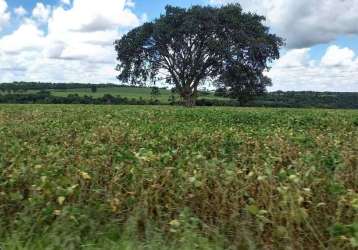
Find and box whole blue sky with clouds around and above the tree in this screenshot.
[0,0,358,92]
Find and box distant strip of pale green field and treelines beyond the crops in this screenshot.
[0,83,358,108]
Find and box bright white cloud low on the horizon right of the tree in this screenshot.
[268,45,358,91]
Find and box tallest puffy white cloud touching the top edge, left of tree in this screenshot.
[43,0,141,62]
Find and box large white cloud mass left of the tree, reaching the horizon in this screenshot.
[0,0,143,82]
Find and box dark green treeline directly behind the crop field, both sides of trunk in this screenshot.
[0,90,358,109]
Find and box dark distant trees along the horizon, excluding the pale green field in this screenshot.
[0,82,358,109]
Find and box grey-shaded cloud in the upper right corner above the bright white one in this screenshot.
[210,0,358,49]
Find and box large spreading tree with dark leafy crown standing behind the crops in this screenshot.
[115,4,283,106]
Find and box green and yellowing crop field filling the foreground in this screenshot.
[0,105,358,250]
